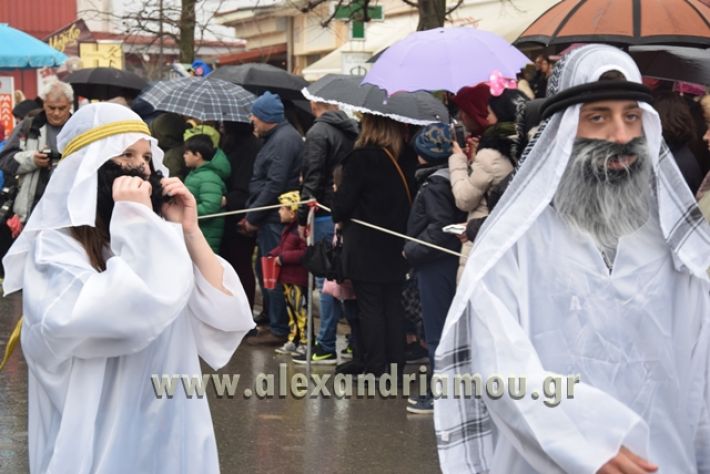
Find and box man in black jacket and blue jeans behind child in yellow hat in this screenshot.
[294,101,358,364]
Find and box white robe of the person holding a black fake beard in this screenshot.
[22,202,253,474]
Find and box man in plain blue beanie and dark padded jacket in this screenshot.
[239,91,303,345]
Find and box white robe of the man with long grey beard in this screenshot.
[469,207,710,474]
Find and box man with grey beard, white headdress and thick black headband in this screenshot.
[434,45,710,474]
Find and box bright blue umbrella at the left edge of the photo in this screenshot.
[0,23,67,69]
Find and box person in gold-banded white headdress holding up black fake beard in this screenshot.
[3,104,253,473]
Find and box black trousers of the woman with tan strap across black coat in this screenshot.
[353,281,404,376]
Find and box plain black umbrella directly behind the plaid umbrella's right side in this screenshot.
[207,63,308,100]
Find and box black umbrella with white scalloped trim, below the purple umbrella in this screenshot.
[302,74,449,125]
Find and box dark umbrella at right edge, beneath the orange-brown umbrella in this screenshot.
[629,46,710,85]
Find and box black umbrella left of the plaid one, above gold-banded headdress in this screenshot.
[64,67,148,100]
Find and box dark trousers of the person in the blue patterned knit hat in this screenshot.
[416,256,459,372]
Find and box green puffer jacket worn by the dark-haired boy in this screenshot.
[185,149,231,253]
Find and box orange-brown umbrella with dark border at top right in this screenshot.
[515,0,710,47]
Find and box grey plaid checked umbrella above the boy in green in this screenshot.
[140,77,256,122]
